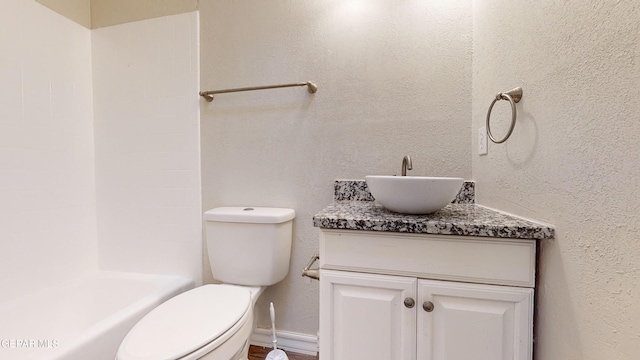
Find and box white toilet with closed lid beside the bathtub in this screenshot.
[116,207,295,360]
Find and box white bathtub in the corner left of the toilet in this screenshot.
[0,271,194,360]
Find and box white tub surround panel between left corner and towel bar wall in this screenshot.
[92,12,202,281]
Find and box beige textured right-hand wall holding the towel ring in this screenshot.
[473,0,640,360]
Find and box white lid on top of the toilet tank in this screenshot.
[204,206,296,224]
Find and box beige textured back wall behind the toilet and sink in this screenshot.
[199,0,472,335]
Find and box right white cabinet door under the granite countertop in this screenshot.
[417,280,533,360]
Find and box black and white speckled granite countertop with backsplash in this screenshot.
[313,180,555,239]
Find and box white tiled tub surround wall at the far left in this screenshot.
[0,0,97,302]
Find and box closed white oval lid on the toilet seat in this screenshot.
[117,285,251,360]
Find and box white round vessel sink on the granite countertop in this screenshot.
[364,175,464,214]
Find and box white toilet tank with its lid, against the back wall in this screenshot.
[204,207,295,286]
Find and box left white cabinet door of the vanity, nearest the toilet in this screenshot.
[320,270,417,360]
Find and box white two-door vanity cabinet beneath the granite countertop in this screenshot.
[319,229,536,360]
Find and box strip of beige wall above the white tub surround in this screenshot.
[36,0,198,29]
